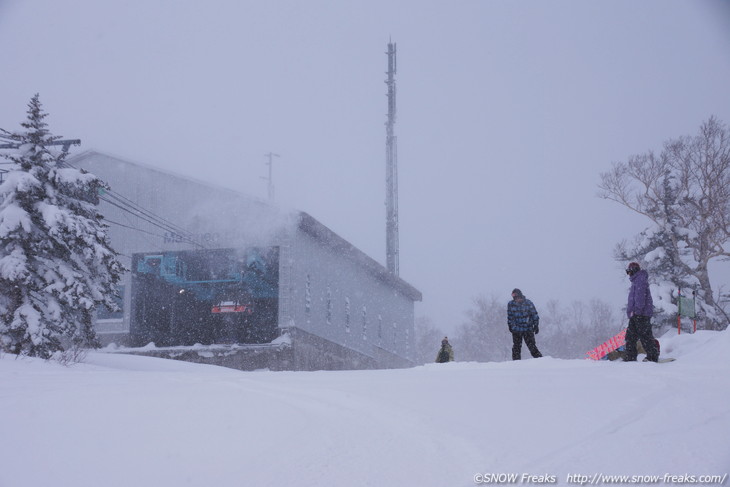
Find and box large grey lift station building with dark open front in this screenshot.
[68,151,421,370]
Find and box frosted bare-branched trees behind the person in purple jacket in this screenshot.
[599,117,730,329]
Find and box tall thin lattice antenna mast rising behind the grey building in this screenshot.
[385,42,400,276]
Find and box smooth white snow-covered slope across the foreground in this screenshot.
[0,331,730,487]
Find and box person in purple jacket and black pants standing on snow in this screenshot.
[624,262,659,362]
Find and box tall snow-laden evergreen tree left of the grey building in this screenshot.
[0,94,123,358]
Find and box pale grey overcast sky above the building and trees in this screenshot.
[0,0,730,330]
